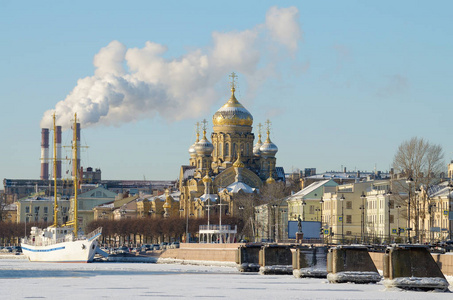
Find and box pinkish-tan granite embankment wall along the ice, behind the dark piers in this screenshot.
[153,243,453,276]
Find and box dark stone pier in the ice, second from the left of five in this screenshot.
[259,245,293,275]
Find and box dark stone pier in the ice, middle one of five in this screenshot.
[291,246,327,278]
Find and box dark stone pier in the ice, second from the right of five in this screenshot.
[327,246,381,283]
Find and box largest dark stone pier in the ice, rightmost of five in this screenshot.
[384,245,448,291]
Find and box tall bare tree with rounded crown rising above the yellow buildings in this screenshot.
[392,137,445,241]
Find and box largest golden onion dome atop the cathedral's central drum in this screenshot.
[212,87,253,126]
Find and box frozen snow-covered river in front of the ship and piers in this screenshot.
[0,259,453,300]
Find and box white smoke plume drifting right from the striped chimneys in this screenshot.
[41,7,302,128]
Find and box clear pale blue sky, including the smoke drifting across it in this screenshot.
[0,1,453,188]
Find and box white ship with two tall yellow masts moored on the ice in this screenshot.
[21,114,102,263]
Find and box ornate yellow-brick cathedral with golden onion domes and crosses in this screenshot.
[179,73,285,218]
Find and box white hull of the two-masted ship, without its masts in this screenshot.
[21,239,98,263]
